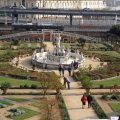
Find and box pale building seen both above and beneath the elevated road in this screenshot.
[0,0,106,22]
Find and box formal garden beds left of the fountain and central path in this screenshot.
[0,40,69,120]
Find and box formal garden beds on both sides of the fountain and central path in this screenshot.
[0,24,120,120]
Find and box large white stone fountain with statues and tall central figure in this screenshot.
[32,34,85,69]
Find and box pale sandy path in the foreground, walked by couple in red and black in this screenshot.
[61,77,98,120]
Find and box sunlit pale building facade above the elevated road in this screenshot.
[0,0,106,9]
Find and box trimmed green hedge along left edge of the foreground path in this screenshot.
[56,94,70,120]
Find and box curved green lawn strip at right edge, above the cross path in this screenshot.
[93,78,120,87]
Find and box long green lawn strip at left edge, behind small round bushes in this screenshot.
[0,77,40,87]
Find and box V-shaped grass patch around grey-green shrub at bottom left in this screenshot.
[12,107,39,120]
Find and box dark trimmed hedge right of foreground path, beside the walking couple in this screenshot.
[92,99,108,119]
